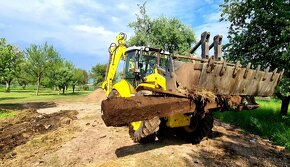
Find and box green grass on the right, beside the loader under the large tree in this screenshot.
[214,100,290,150]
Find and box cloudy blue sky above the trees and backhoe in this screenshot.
[0,0,228,70]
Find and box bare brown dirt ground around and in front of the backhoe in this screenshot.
[0,90,290,167]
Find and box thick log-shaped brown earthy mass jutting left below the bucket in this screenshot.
[102,96,195,126]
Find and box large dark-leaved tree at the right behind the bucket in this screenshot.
[221,0,290,115]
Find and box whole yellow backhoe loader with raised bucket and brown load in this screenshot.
[101,32,283,143]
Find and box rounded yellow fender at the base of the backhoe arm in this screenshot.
[113,79,136,97]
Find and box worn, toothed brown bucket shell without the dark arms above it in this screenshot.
[175,59,283,96]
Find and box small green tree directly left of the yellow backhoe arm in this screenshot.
[90,64,107,86]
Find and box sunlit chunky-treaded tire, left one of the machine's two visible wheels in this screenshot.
[129,117,160,144]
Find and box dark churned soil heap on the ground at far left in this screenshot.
[0,109,78,160]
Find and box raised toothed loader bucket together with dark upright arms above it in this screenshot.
[169,31,283,96]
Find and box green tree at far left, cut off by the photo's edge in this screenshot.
[0,38,23,92]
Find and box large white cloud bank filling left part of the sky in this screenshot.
[0,0,137,55]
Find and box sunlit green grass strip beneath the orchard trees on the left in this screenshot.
[0,89,92,104]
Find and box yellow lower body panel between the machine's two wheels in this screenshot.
[166,114,191,128]
